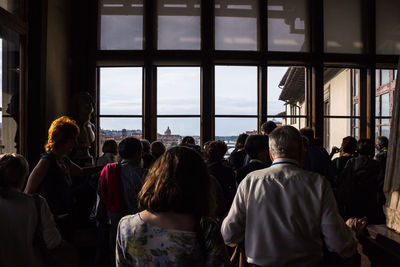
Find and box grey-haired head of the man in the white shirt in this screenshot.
[268,125,303,159]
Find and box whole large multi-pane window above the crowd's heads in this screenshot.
[96,0,400,154]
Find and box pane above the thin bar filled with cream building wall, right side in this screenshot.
[324,68,355,116]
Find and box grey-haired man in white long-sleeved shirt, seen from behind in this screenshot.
[221,126,357,266]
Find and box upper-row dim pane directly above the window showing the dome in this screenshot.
[157,0,201,50]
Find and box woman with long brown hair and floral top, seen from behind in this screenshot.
[116,147,226,266]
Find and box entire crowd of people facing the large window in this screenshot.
[0,116,388,266]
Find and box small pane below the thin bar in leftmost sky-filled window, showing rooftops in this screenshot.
[99,118,142,152]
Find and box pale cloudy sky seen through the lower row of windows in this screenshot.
[100,66,287,136]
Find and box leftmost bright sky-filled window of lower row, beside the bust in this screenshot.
[99,67,143,151]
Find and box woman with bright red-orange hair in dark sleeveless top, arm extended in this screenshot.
[25,116,103,238]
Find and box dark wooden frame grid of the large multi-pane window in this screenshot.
[95,0,397,155]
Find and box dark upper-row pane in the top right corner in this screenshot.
[376,0,400,55]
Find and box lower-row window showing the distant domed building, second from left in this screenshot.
[157,67,200,148]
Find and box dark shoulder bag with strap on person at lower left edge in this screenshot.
[33,194,77,267]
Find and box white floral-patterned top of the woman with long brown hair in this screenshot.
[116,214,225,267]
